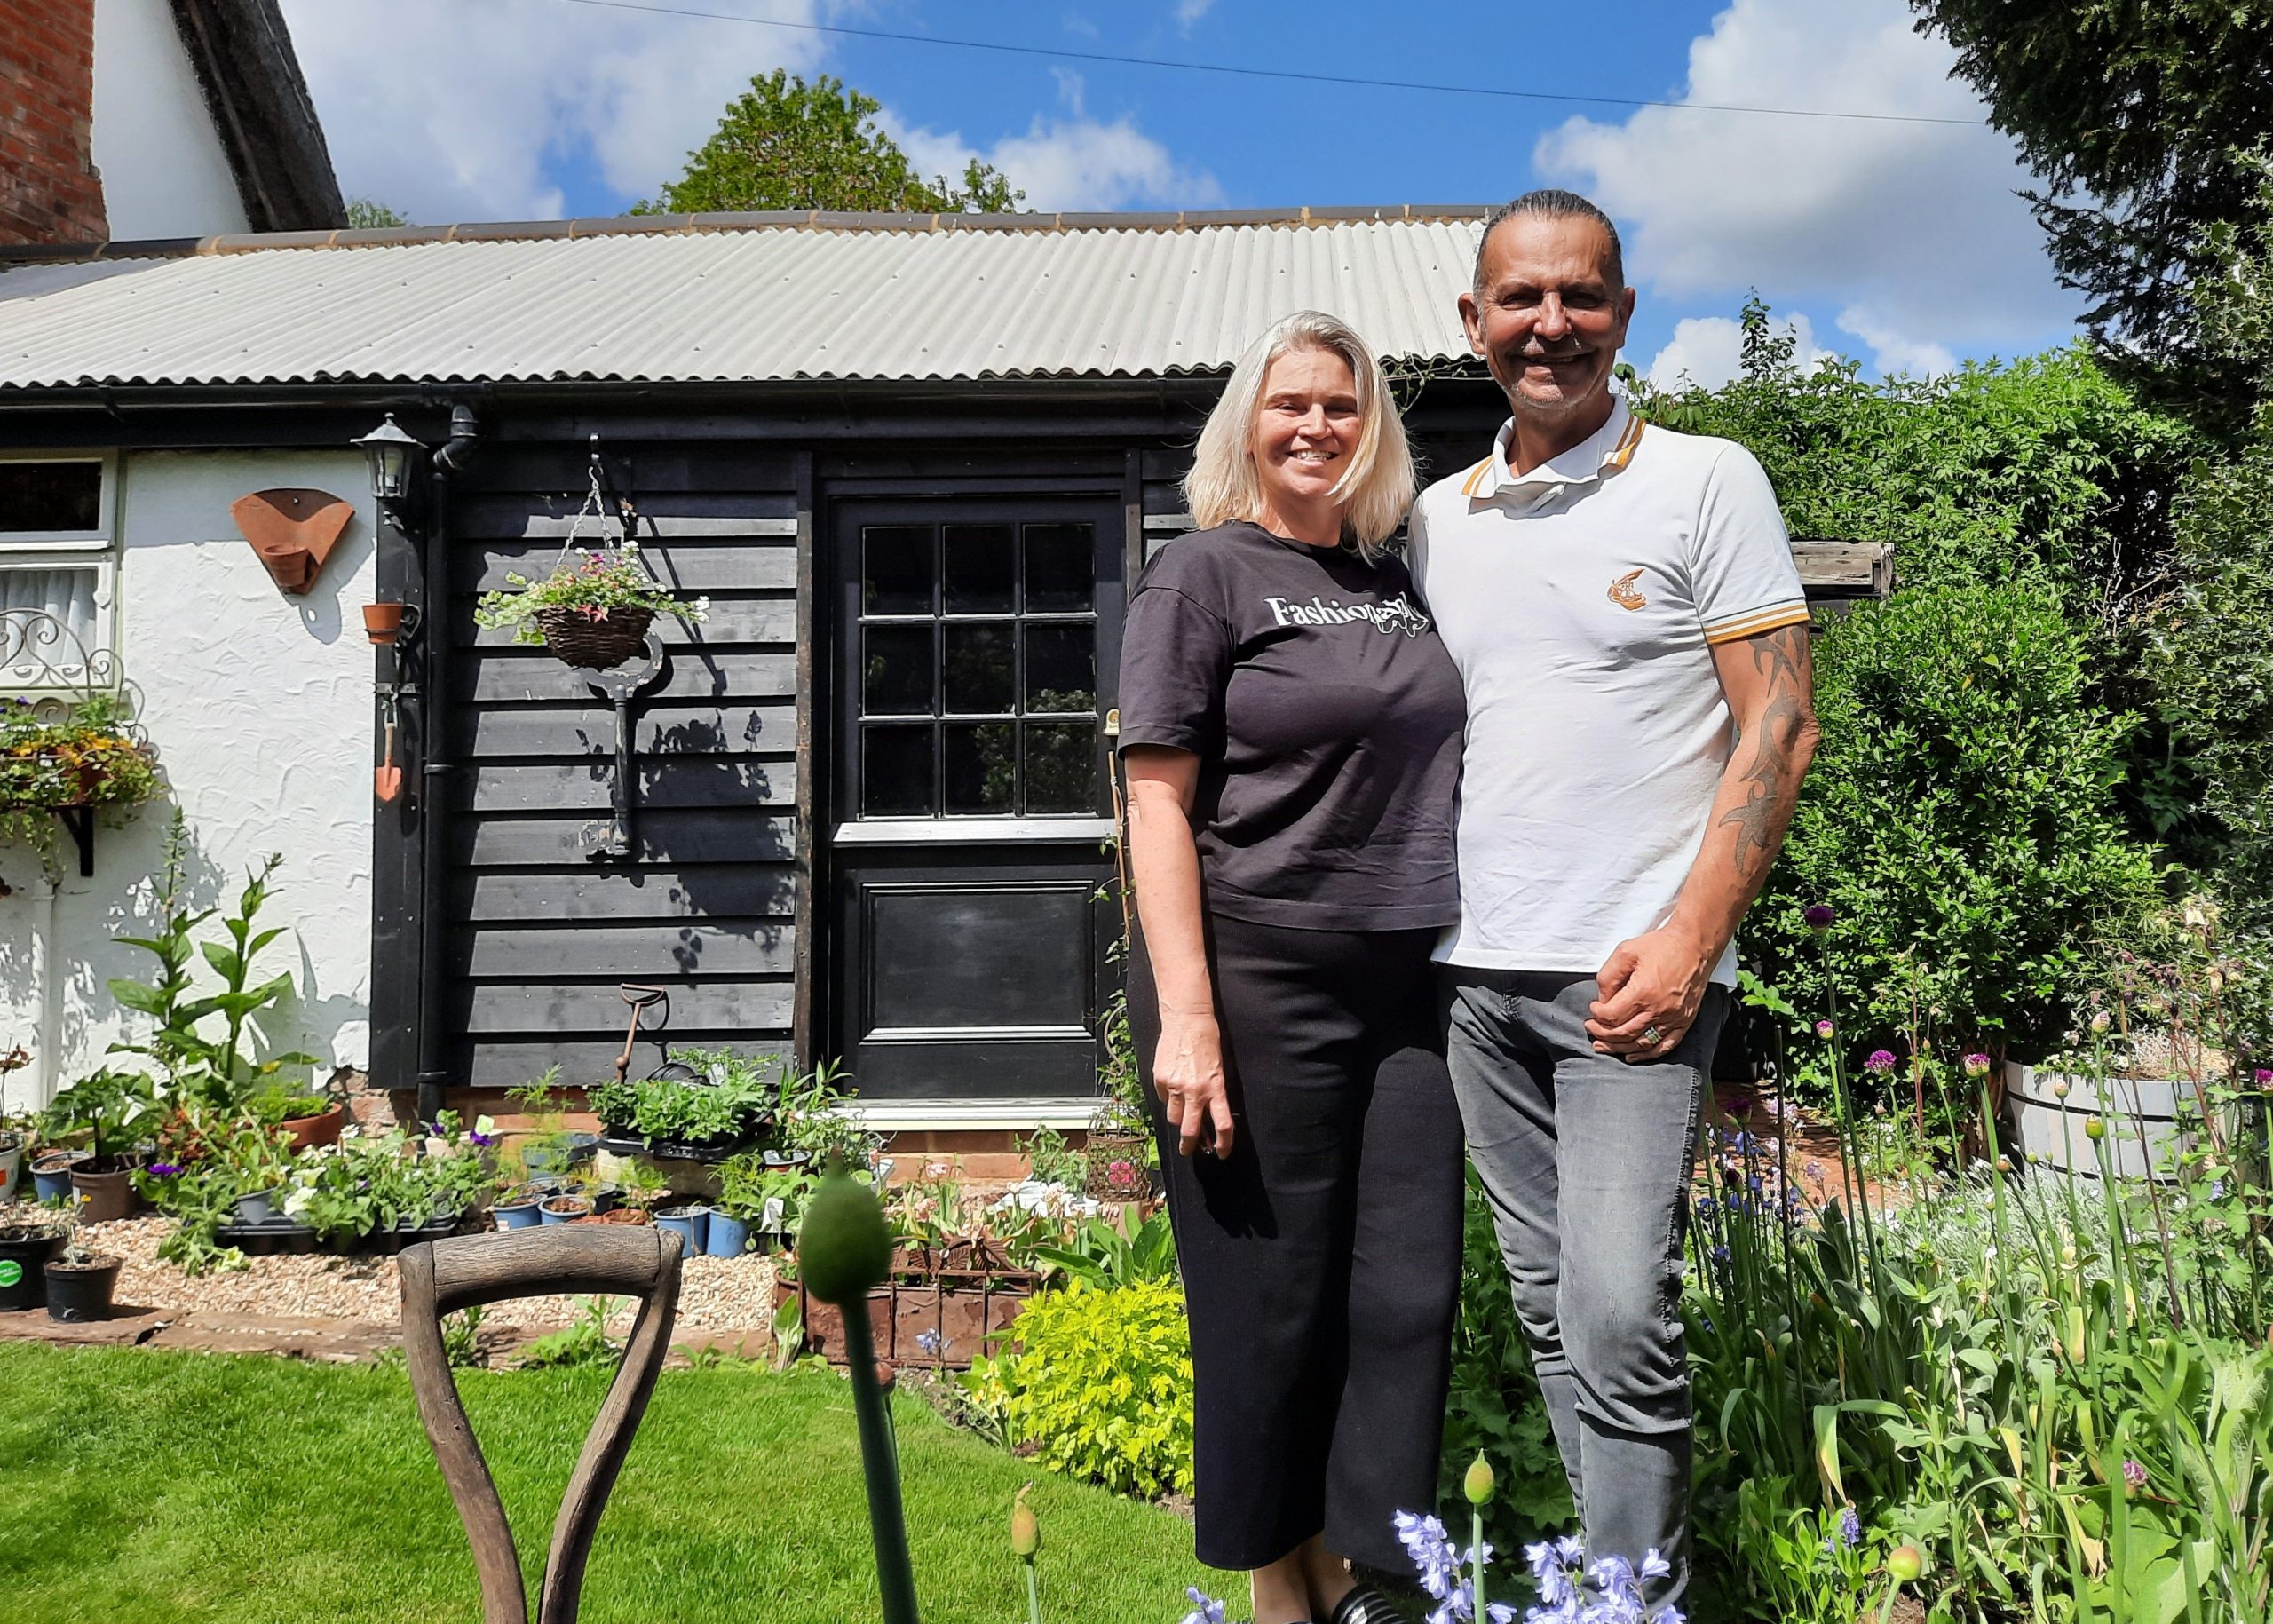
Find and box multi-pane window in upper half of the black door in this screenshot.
[857,523,1097,817]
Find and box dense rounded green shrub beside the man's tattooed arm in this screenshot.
[1746,584,2155,1058]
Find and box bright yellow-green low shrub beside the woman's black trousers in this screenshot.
[966,1280,1191,1497]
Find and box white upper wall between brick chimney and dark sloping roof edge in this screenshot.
[89,0,250,242]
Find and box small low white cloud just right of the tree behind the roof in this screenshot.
[880,112,1223,211]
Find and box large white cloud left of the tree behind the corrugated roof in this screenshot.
[284,0,825,223]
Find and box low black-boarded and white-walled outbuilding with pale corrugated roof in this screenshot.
[0,207,1887,1129]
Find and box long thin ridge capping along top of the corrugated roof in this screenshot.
[0,202,1489,264]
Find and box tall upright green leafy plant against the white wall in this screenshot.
[109,807,316,1105]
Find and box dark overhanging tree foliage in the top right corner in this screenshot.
[1912,0,2273,423]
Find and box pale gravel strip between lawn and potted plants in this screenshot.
[84,1216,772,1331]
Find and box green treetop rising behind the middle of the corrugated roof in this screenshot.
[634,68,1026,214]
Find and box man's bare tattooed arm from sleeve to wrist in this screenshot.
[1668,623,1816,960]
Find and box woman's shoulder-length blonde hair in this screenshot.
[1184,309,1414,559]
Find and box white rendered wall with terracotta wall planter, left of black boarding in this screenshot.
[0,450,373,1110]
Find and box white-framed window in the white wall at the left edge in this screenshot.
[0,450,118,693]
